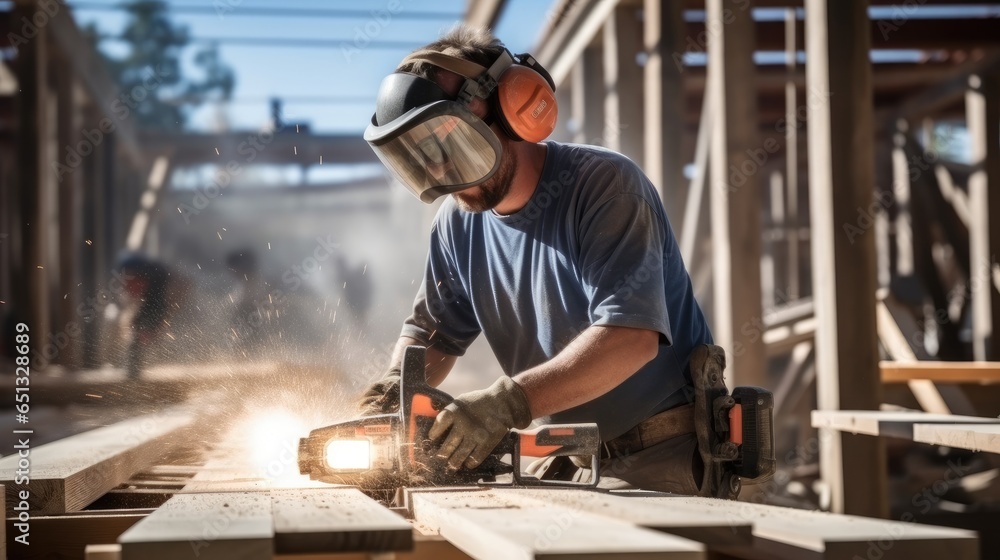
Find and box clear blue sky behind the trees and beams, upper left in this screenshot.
[68,0,553,133]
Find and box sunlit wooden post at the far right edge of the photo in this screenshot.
[965,75,1000,360]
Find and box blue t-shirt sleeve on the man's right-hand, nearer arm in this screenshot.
[580,193,673,344]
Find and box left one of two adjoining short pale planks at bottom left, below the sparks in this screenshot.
[118,493,274,560]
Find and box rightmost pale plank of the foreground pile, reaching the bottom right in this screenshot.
[646,497,979,560]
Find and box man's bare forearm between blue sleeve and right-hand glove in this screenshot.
[514,326,660,418]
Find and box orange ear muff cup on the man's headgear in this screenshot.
[497,64,559,142]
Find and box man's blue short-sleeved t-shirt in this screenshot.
[402,142,712,440]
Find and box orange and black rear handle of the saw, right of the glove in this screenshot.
[510,424,601,488]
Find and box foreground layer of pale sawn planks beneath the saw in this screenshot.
[0,412,978,560]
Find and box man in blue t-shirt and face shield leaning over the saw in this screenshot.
[361,26,712,494]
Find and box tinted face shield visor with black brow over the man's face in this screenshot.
[365,73,502,203]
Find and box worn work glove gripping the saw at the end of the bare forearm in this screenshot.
[427,376,531,470]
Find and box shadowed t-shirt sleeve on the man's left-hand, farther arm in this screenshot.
[401,225,481,356]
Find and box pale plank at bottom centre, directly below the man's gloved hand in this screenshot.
[409,489,705,560]
